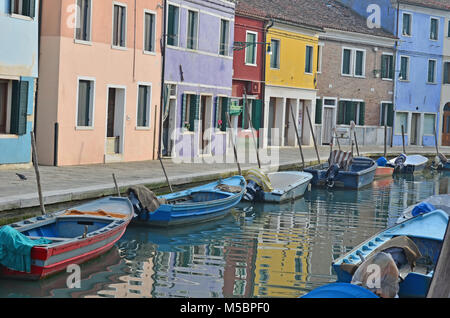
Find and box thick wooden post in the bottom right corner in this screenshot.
[427,221,450,298]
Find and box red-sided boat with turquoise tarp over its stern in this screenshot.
[0,197,134,280]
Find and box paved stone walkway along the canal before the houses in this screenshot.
[0,146,450,218]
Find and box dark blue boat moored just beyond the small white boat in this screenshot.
[304,157,377,189]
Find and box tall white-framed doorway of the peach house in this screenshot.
[106,87,125,156]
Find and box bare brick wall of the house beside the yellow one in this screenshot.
[317,39,394,126]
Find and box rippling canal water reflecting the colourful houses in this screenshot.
[0,172,450,298]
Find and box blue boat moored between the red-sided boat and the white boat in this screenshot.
[129,176,247,227]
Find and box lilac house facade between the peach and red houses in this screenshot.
[162,0,235,158]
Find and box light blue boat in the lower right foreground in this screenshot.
[332,210,449,298]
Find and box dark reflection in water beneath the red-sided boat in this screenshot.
[0,246,126,298]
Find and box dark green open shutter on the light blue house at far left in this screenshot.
[11,81,29,136]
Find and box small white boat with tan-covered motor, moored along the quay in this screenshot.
[244,169,313,203]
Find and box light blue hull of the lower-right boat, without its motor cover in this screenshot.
[332,210,449,298]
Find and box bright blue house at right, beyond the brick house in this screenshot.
[341,0,449,146]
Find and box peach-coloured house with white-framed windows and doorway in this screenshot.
[36,0,163,166]
